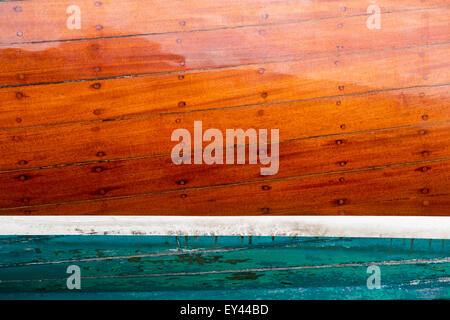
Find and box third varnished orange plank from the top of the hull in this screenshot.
[0,45,450,129]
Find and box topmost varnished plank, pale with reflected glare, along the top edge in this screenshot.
[0,0,448,43]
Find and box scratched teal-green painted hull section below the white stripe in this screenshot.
[0,236,450,299]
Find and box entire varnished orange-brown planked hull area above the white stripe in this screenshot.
[0,0,450,215]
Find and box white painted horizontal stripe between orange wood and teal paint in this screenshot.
[0,216,450,239]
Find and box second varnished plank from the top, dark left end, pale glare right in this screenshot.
[0,7,450,86]
